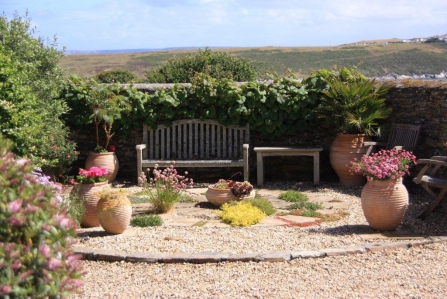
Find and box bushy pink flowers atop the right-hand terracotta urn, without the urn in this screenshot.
[350,149,416,181]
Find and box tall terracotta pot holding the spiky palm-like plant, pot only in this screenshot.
[329,134,372,186]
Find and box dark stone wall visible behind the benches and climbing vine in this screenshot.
[72,80,447,183]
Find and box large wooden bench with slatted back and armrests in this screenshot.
[136,119,250,181]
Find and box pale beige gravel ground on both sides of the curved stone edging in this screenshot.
[68,183,447,298]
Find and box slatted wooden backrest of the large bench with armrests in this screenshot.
[143,119,250,160]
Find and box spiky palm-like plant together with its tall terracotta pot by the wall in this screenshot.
[316,68,391,186]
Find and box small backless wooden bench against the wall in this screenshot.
[254,147,323,187]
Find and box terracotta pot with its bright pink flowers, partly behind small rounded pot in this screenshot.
[71,167,109,227]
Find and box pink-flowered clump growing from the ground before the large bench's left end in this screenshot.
[138,162,194,213]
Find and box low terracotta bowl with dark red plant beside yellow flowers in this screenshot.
[205,179,255,207]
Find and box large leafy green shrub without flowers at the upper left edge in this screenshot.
[0,12,77,177]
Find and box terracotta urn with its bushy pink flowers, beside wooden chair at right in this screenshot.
[351,149,416,230]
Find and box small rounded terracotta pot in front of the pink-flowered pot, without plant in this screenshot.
[96,193,132,234]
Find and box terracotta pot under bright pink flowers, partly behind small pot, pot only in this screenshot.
[71,182,109,227]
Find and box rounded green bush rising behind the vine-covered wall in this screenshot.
[146,49,257,83]
